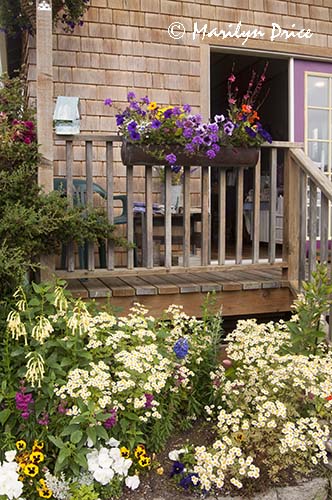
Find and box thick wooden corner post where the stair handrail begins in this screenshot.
[283,149,303,288]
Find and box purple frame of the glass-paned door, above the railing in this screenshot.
[294,59,332,142]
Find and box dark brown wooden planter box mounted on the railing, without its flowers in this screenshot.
[121,141,259,168]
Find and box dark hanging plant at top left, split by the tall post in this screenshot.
[0,0,90,35]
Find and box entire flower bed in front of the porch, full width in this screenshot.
[0,266,332,500]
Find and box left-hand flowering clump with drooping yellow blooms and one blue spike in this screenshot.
[0,284,220,499]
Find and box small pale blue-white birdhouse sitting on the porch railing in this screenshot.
[53,96,81,135]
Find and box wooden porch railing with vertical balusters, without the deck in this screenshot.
[55,135,332,285]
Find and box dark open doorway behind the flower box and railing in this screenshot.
[210,51,289,258]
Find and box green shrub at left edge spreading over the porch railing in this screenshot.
[0,76,125,298]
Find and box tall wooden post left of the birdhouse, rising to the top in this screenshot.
[36,0,55,280]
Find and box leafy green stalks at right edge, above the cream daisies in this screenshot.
[287,264,332,356]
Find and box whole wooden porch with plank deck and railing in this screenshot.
[50,135,332,328]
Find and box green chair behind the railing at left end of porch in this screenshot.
[53,177,128,269]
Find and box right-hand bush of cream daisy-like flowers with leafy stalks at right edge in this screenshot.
[171,266,332,494]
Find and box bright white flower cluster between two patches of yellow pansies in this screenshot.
[86,439,140,490]
